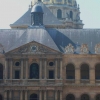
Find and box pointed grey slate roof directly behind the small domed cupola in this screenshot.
[10,2,62,26]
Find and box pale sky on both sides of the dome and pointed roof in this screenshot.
[0,0,100,29]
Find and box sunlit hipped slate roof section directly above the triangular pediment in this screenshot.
[6,28,60,52]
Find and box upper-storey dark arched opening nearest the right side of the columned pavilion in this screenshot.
[66,64,75,79]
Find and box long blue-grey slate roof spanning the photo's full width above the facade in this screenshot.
[0,27,100,54]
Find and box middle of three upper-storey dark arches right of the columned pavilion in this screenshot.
[81,64,89,79]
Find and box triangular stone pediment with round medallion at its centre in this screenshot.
[9,42,60,54]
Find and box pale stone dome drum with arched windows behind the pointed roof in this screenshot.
[32,0,84,28]
